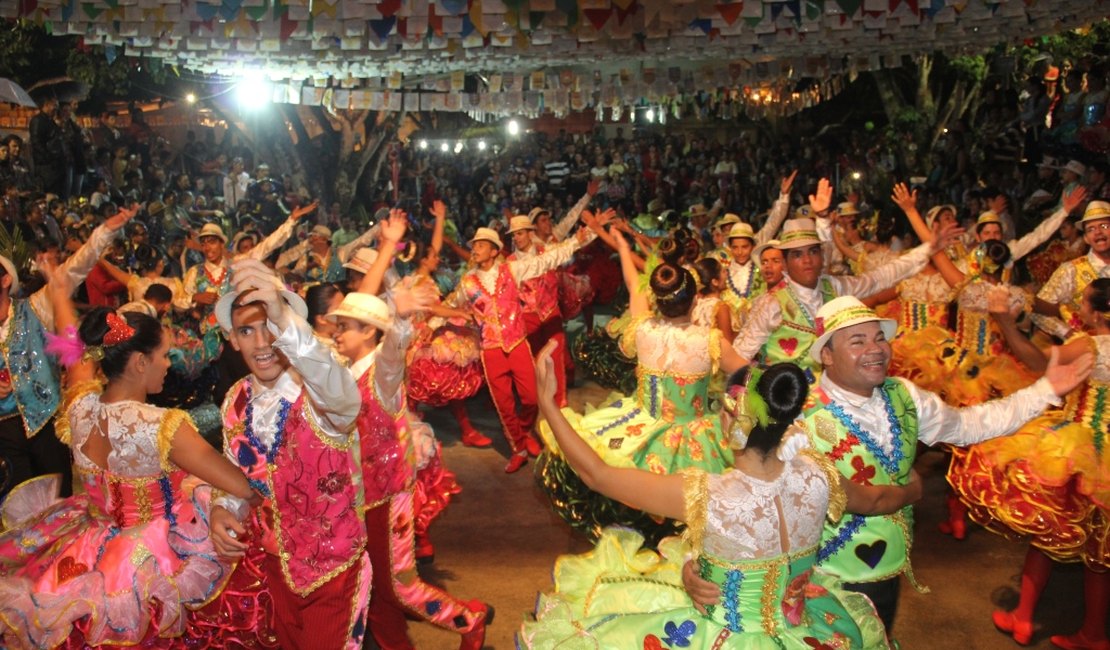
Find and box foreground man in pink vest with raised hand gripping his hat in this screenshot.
[204,260,371,650]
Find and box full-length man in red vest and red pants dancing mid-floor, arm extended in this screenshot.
[446,216,595,474]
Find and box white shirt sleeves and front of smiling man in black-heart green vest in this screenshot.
[810,373,1061,453]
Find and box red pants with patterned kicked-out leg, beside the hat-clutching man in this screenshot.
[366,490,485,650]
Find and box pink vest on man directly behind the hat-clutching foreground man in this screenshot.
[356,365,413,508]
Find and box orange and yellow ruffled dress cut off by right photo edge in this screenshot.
[948,335,1110,570]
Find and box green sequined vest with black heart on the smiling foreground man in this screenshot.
[804,378,917,586]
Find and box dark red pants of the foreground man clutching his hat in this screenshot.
[262,545,370,650]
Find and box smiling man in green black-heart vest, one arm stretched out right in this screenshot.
[683,296,1093,633]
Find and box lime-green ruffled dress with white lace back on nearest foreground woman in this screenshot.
[517,451,889,650]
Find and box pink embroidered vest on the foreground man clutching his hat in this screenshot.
[223,377,366,597]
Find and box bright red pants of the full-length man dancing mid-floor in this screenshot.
[482,342,536,454]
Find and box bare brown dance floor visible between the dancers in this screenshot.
[399,383,1082,650]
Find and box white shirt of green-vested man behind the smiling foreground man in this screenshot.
[733,244,931,360]
